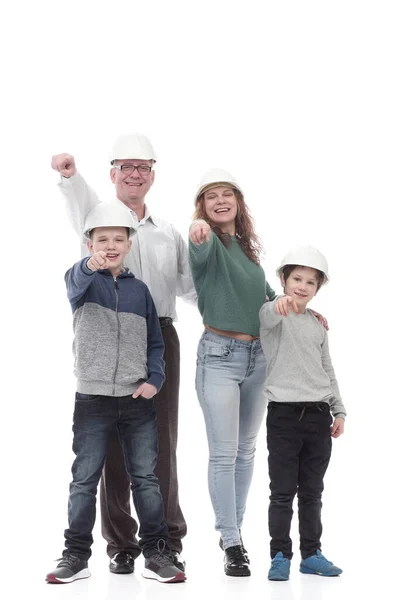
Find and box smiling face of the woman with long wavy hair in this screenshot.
[201,185,238,235]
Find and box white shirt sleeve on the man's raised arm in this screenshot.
[58,172,100,257]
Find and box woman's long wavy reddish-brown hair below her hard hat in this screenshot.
[193,184,263,265]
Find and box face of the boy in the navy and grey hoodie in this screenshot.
[87,227,132,277]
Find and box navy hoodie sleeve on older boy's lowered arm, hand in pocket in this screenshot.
[146,288,165,391]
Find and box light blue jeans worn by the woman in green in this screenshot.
[196,331,267,548]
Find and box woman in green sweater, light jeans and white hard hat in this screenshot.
[189,169,276,577]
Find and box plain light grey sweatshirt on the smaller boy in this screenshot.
[259,300,346,418]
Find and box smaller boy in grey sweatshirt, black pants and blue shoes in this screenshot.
[260,246,346,581]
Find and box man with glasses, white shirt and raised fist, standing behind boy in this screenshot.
[51,134,196,574]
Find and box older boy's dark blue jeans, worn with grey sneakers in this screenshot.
[64,392,168,559]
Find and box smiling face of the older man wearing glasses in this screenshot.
[110,158,155,208]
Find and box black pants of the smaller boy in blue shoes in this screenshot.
[267,402,332,559]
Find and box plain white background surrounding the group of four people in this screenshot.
[0,0,403,600]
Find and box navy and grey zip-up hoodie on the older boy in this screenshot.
[65,256,165,396]
